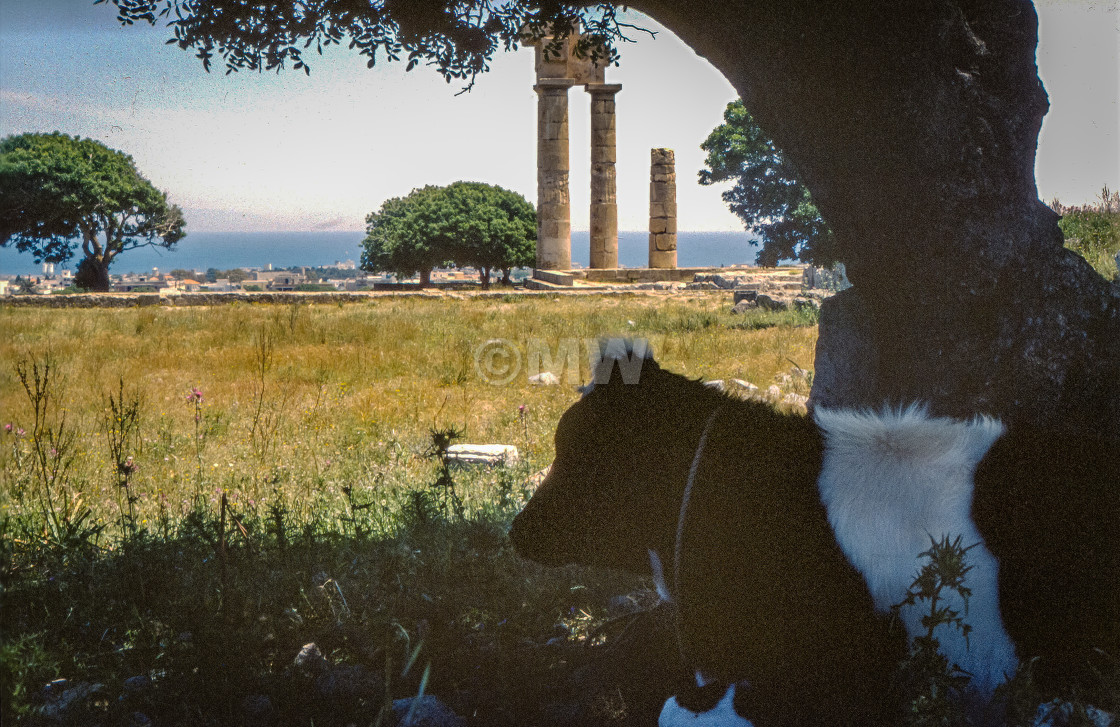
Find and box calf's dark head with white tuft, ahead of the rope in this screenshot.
[510,341,725,574]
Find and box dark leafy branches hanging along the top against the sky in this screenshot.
[95,0,627,87]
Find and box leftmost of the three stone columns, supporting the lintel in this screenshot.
[533,78,575,270]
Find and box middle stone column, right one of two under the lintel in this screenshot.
[585,83,622,268]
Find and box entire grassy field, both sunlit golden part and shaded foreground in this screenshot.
[0,296,816,725]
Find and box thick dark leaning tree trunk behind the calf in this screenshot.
[634,0,1120,436]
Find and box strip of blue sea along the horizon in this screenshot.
[0,231,758,276]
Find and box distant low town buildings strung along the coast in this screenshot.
[0,260,532,296]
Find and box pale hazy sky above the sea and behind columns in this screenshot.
[0,0,1120,231]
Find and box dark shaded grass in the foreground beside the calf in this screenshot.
[0,499,675,726]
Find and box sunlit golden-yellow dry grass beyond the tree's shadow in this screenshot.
[0,298,815,529]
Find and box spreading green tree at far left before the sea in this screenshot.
[0,132,186,290]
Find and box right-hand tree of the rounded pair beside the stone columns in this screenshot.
[445,181,536,290]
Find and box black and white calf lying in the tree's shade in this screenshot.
[511,342,1120,727]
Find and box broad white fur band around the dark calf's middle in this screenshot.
[814,406,1018,693]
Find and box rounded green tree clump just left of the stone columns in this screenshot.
[362,181,536,288]
